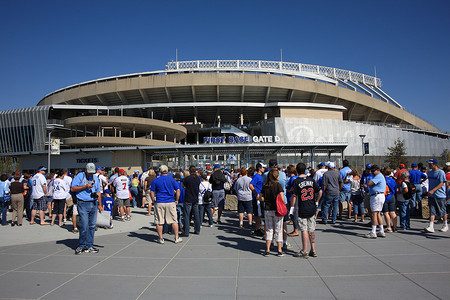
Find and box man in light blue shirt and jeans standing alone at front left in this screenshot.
[70,163,103,255]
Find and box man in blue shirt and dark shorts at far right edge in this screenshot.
[425,158,448,233]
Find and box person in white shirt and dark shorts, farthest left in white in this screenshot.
[30,166,50,225]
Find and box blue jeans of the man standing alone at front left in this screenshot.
[77,200,97,249]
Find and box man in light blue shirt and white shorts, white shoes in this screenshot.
[365,165,386,239]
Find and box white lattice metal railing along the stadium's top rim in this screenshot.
[166,60,382,87]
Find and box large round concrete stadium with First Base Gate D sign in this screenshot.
[0,60,450,170]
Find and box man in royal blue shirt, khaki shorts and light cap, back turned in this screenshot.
[150,165,183,244]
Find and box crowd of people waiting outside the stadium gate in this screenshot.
[0,159,450,258]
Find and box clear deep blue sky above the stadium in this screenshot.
[0,0,450,131]
